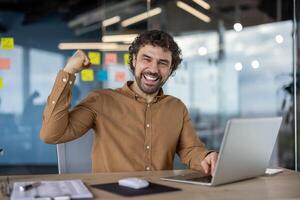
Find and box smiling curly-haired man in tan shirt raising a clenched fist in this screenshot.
[40,30,218,175]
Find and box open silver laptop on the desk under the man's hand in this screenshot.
[161,117,282,186]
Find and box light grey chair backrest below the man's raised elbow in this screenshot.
[56,130,94,174]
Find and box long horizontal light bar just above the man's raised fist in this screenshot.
[58,42,129,51]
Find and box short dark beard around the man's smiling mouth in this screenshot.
[135,71,166,94]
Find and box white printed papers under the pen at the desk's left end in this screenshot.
[11,180,93,200]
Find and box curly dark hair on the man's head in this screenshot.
[129,30,182,74]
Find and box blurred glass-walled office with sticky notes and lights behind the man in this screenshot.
[0,0,300,175]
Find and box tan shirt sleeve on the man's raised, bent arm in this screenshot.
[40,70,97,144]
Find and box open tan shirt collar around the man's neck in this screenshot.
[118,81,164,103]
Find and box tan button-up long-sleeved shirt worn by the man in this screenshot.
[40,70,209,172]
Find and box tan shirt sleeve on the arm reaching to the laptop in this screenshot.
[177,107,211,170]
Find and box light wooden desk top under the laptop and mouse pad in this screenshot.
[0,170,300,200]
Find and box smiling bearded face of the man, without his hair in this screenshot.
[133,44,172,94]
